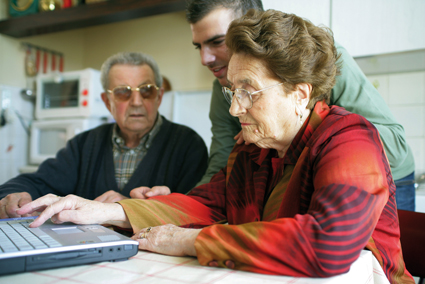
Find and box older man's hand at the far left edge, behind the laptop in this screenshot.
[0,192,33,219]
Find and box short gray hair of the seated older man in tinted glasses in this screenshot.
[100,52,162,91]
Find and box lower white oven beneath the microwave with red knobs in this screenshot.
[29,118,107,165]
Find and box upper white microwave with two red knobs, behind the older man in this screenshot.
[35,68,109,119]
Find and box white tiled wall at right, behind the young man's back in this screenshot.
[355,49,425,212]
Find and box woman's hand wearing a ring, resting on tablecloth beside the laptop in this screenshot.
[132,224,201,256]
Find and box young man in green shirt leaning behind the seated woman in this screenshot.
[186,0,415,211]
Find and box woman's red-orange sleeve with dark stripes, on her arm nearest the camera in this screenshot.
[195,115,391,277]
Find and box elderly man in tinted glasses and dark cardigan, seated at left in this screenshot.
[0,53,208,218]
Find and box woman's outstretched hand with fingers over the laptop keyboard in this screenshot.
[16,194,130,228]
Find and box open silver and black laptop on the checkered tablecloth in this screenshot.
[0,217,139,275]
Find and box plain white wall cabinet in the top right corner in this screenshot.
[331,0,425,57]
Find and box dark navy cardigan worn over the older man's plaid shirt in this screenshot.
[0,117,208,199]
